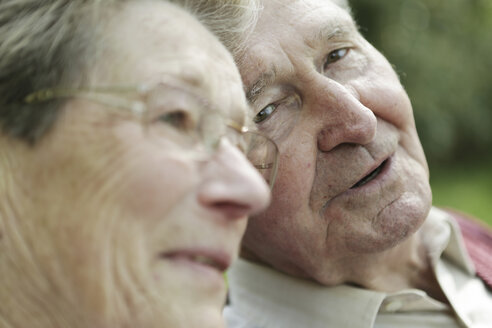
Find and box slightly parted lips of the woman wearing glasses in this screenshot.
[160,249,231,273]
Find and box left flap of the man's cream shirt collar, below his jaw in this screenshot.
[228,260,386,327]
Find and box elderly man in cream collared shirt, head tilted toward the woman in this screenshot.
[196,0,492,328]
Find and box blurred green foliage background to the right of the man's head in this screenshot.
[349,0,492,225]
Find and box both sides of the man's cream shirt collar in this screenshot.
[226,208,488,328]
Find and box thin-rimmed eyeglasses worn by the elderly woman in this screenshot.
[24,82,278,188]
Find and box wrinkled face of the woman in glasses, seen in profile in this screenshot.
[4,1,269,328]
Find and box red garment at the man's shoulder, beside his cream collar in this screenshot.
[445,209,492,289]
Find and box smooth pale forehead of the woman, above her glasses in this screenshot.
[99,2,246,122]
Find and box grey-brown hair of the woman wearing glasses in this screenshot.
[0,0,115,143]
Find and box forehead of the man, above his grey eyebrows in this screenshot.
[239,0,358,96]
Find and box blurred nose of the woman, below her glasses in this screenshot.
[198,140,270,220]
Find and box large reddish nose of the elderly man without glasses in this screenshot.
[313,78,377,151]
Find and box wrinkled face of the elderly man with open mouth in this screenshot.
[238,0,431,284]
